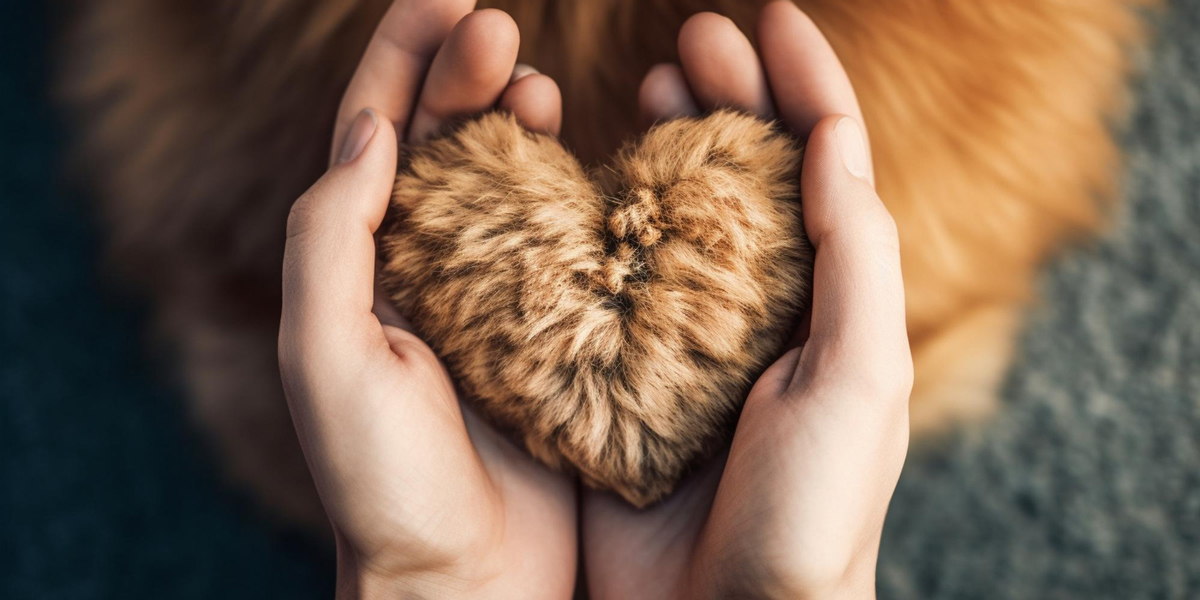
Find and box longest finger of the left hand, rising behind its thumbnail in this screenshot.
[330,0,475,163]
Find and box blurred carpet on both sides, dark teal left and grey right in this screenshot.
[7,0,1200,599]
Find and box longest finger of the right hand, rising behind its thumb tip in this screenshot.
[758,1,875,182]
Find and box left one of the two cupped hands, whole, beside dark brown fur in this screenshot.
[280,0,577,598]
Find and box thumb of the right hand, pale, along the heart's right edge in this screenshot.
[798,116,912,393]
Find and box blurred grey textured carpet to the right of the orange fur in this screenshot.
[880,0,1200,599]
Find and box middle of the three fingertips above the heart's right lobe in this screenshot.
[679,12,774,116]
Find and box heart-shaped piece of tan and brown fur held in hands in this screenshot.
[380,110,812,506]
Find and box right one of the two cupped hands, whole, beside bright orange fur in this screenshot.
[582,1,912,599]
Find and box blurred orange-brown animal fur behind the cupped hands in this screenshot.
[59,0,1153,527]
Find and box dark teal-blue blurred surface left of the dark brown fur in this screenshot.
[0,2,332,599]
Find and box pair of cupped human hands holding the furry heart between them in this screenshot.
[280,0,912,599]
